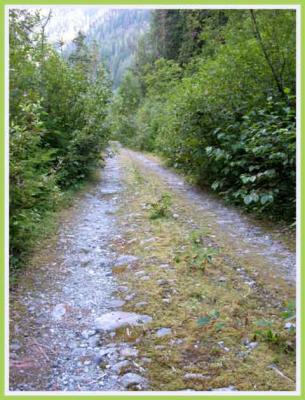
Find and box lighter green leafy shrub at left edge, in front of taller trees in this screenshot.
[10,102,60,266]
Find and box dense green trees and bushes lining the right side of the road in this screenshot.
[110,10,295,223]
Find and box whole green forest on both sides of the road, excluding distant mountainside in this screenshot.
[10,10,296,265]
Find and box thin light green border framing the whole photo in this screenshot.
[0,0,305,400]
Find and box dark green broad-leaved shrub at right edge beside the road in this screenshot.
[206,97,296,220]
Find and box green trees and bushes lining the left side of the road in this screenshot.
[10,10,111,268]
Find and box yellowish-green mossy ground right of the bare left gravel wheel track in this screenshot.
[113,153,295,391]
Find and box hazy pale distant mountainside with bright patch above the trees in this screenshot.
[43,6,151,88]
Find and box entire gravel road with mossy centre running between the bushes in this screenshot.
[10,149,295,391]
